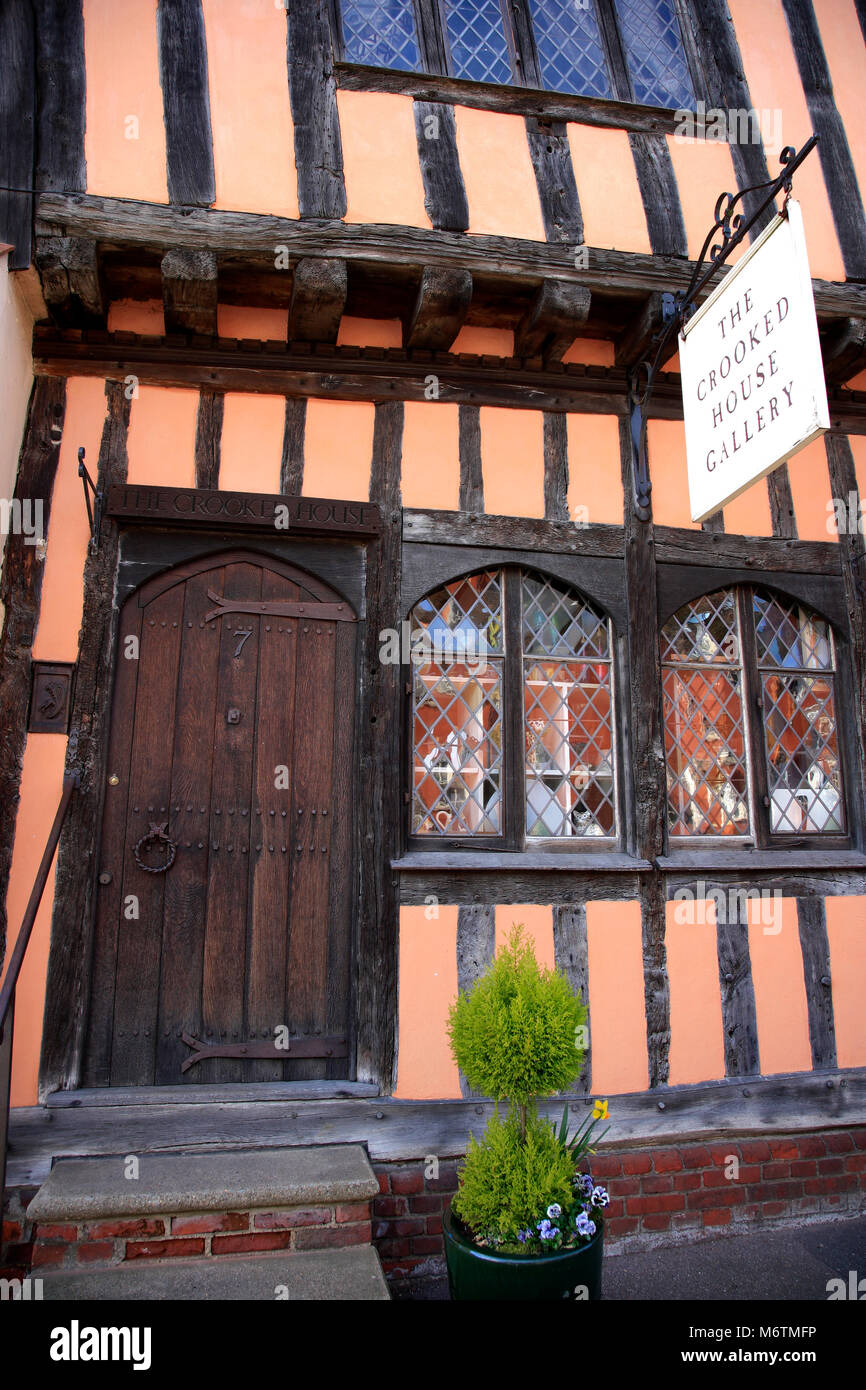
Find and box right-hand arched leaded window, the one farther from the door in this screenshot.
[662,587,845,845]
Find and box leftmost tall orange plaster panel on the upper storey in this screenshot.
[83,0,168,203]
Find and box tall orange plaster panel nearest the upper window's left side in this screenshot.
[201,0,297,217]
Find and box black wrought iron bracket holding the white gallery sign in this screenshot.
[628,135,817,521]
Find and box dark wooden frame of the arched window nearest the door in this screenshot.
[403,557,627,856]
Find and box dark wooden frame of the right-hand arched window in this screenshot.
[660,581,858,855]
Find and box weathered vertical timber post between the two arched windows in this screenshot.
[620,416,670,1087]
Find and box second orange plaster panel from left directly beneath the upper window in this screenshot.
[453,107,545,242]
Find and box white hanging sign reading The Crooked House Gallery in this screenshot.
[680,199,830,521]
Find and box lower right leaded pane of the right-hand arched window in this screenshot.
[762,671,845,835]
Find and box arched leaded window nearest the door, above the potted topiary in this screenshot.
[410,569,617,849]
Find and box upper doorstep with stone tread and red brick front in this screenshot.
[26,1144,379,1275]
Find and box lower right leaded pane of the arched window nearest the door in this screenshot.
[524,659,616,840]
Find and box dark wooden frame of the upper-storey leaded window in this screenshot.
[328,0,706,111]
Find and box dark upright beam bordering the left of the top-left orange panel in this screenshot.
[33,0,88,192]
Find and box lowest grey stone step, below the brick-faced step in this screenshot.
[35,1245,391,1302]
